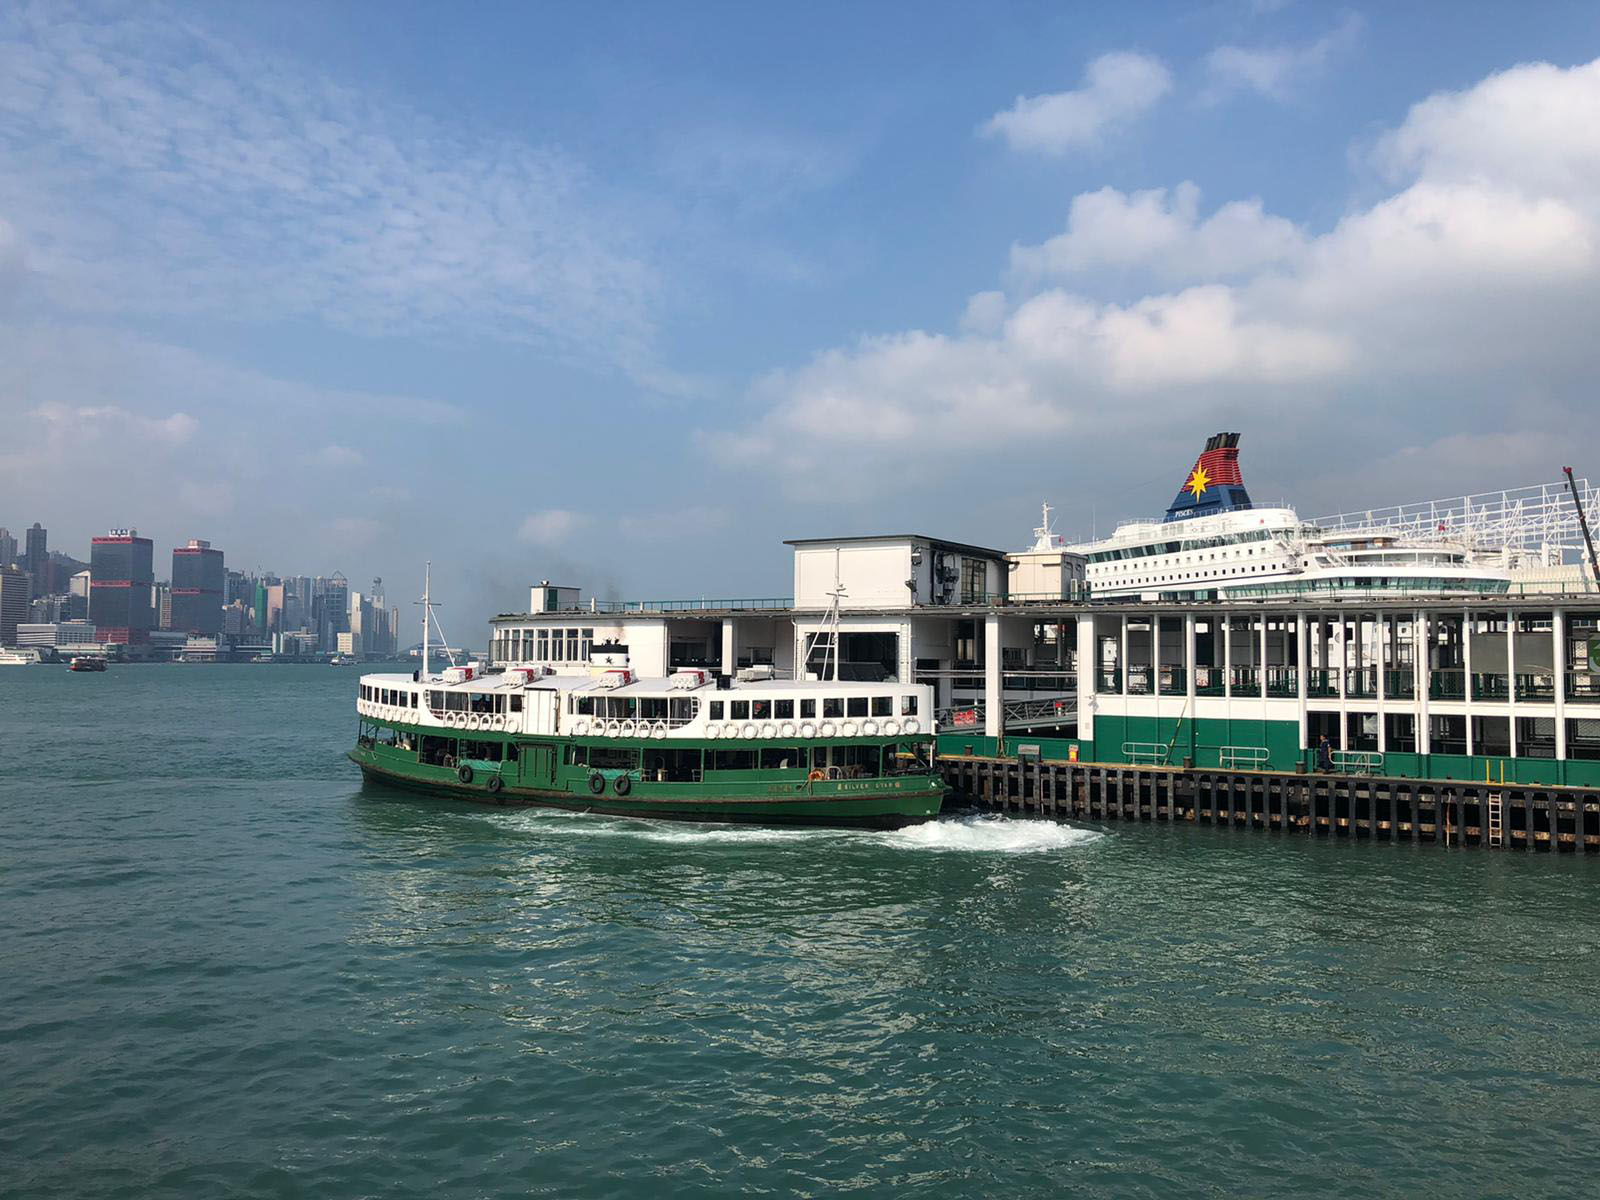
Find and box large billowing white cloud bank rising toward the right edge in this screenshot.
[720,55,1600,501]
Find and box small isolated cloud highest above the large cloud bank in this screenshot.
[982,51,1173,154]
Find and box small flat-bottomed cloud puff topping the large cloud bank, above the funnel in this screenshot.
[1011,182,1306,280]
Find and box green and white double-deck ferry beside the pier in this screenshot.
[350,582,946,829]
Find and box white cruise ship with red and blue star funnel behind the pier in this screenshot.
[1066,434,1512,600]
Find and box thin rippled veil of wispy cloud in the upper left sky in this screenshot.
[0,5,656,365]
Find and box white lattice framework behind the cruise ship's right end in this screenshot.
[1310,478,1600,566]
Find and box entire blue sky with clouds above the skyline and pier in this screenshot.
[0,2,1600,629]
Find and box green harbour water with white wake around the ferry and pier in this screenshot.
[0,666,1600,1197]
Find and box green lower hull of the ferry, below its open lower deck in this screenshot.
[349,747,947,829]
